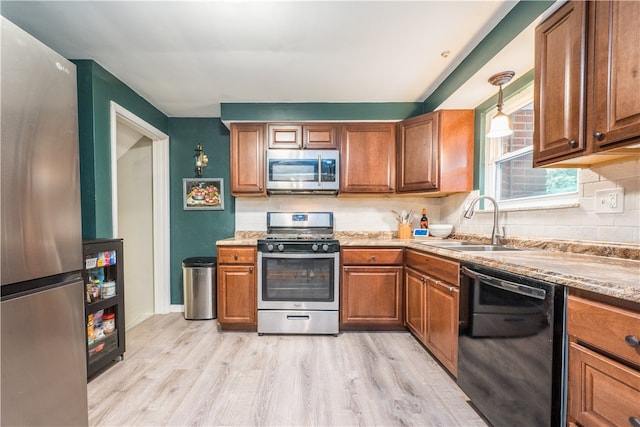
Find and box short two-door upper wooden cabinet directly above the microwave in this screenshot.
[267,123,338,150]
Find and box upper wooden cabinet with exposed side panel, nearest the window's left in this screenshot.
[396,110,474,193]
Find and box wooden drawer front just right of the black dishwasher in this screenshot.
[567,295,640,366]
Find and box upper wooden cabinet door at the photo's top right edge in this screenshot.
[587,1,640,151]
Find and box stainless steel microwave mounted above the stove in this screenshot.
[267,150,340,194]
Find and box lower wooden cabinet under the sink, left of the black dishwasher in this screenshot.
[404,249,460,376]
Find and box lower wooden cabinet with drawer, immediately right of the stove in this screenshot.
[340,248,404,330]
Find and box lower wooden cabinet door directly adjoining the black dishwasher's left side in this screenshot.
[427,278,459,376]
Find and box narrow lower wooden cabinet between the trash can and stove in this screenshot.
[217,246,258,331]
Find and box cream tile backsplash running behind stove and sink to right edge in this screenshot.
[236,159,640,243]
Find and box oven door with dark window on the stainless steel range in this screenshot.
[262,258,336,302]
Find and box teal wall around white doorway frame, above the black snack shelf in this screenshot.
[73,60,168,239]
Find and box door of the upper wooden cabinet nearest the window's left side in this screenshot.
[397,113,439,192]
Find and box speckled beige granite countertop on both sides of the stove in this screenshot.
[216,232,640,304]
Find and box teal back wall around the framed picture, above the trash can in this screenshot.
[169,118,235,304]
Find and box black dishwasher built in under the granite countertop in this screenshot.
[458,264,566,427]
